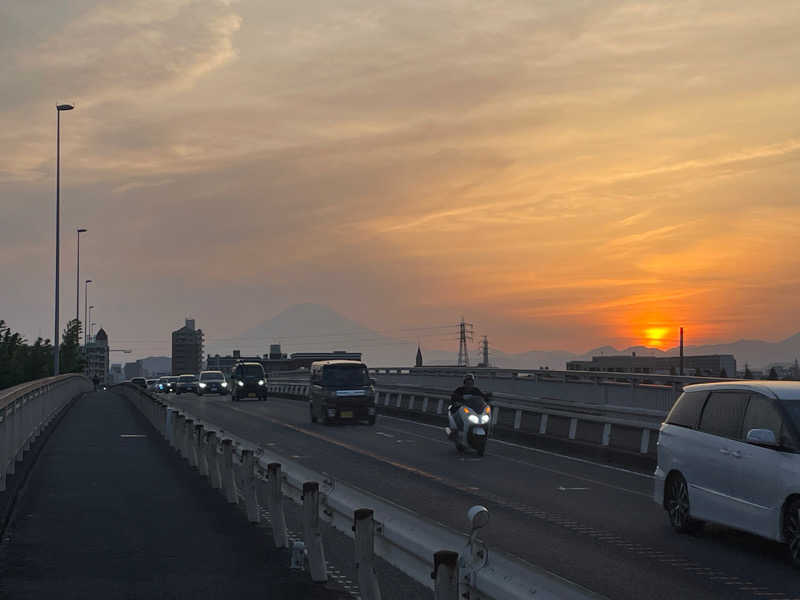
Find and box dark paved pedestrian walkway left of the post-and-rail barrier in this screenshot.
[0,391,343,600]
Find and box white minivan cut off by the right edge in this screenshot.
[654,381,800,568]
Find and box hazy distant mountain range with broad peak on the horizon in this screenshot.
[208,303,800,370]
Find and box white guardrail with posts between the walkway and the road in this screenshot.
[118,384,599,600]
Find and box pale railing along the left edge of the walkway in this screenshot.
[0,374,92,492]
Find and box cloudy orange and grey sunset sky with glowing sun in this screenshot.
[0,0,800,356]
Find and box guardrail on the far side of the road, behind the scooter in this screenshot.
[269,381,667,457]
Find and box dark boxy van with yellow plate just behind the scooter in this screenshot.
[308,360,375,425]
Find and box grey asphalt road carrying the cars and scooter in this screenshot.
[168,394,800,600]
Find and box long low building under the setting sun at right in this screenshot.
[567,353,736,377]
